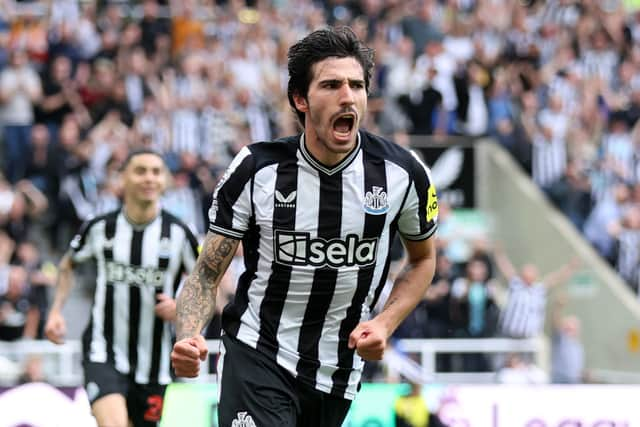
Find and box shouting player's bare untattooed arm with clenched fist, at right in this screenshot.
[349,237,436,360]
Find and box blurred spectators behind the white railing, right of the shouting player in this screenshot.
[376,206,590,384]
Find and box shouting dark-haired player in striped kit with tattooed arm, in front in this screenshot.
[172,28,438,427]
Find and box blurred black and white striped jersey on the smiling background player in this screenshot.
[70,209,198,384]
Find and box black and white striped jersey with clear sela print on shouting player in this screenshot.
[209,131,438,399]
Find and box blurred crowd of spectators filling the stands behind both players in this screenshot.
[0,0,640,388]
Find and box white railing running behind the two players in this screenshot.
[0,338,546,386]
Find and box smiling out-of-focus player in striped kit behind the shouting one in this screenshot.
[45,150,198,427]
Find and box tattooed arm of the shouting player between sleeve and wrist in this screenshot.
[176,236,238,340]
